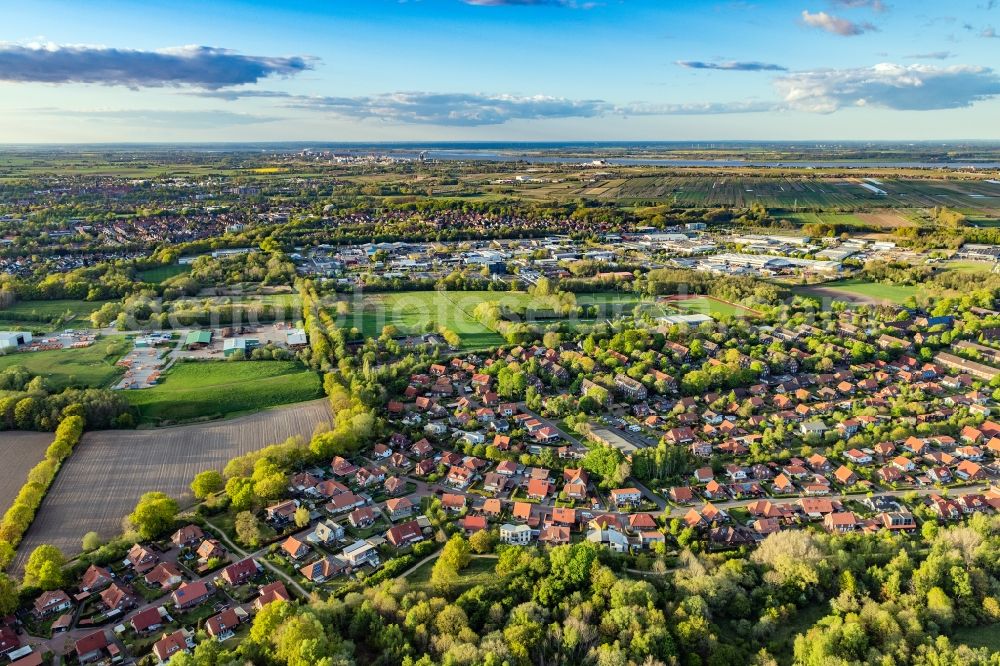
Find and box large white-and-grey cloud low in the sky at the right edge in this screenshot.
[774,63,1000,113]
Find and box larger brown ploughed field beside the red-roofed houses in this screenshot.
[14,400,331,572]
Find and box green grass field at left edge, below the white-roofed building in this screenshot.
[0,336,129,391]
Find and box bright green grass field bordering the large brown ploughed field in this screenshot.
[125,361,323,423]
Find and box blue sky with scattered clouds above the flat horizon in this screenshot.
[0,0,1000,143]
